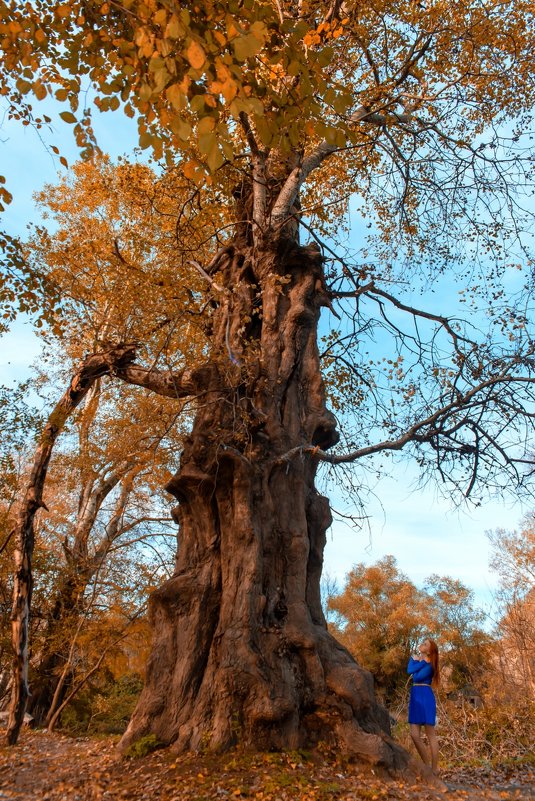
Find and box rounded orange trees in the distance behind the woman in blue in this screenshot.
[328,556,492,709]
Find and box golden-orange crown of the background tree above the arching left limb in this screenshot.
[24,157,232,366]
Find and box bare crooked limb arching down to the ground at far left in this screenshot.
[7,345,135,745]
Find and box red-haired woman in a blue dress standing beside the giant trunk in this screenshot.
[407,639,440,773]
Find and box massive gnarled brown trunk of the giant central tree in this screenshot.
[121,237,405,767]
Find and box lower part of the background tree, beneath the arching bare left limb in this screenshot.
[28,385,180,723]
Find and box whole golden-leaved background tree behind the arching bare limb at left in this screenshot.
[3,159,211,724]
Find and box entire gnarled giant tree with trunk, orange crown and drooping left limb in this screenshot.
[0,0,535,766]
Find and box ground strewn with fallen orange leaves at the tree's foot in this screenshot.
[0,731,535,801]
